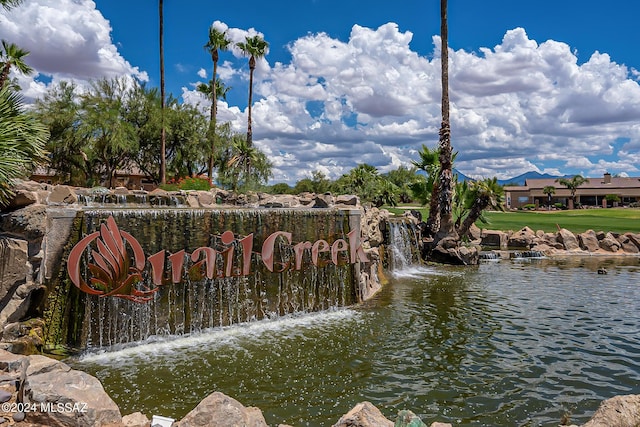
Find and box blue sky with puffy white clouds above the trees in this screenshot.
[0,0,640,184]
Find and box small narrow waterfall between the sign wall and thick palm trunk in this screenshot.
[387,218,421,271]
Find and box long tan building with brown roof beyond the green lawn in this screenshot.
[504,173,640,209]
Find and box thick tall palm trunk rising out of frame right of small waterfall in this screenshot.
[437,0,457,238]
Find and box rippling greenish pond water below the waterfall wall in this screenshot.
[71,258,640,426]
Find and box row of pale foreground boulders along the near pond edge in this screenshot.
[0,350,640,427]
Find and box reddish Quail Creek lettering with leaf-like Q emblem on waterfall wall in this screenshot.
[67,216,369,303]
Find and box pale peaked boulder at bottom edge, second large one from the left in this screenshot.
[177,392,267,427]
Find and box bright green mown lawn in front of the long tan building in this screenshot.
[387,207,640,233]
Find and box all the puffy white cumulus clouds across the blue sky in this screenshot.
[5,0,640,182]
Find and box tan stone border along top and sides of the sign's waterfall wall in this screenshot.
[0,181,388,354]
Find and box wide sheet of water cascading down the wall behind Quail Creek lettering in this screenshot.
[46,208,360,349]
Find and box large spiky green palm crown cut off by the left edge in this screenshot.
[0,87,49,206]
